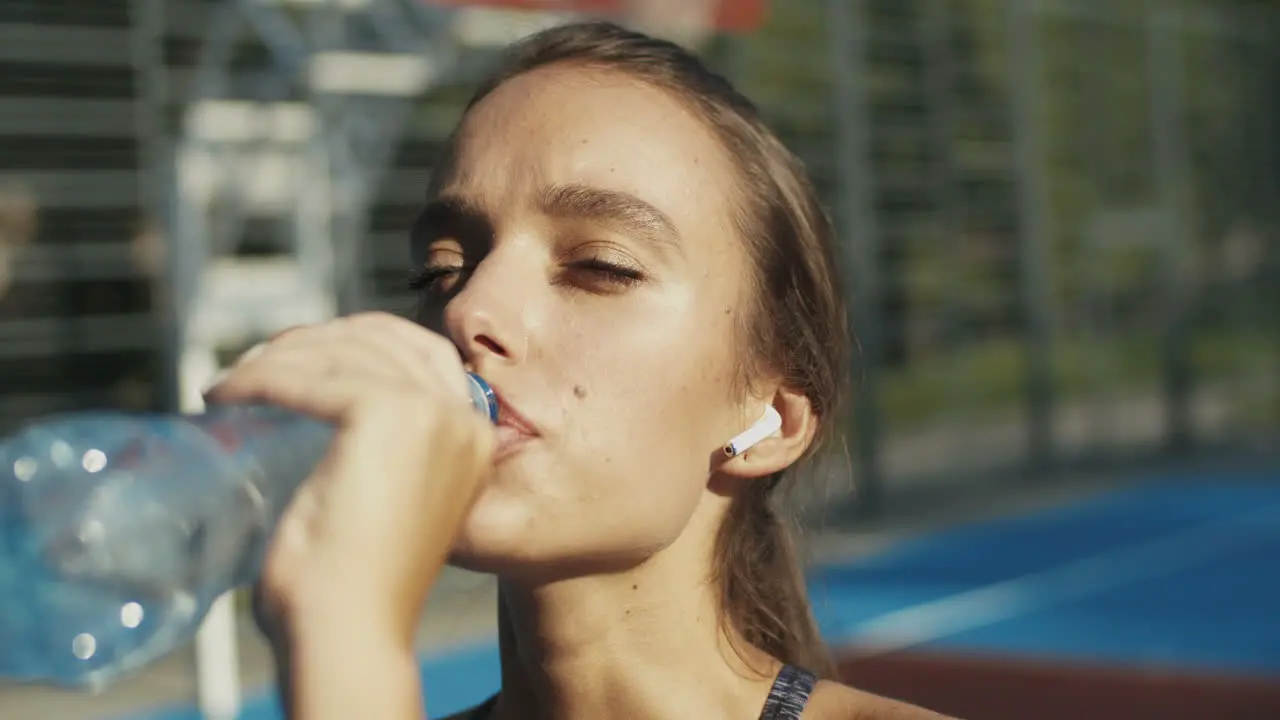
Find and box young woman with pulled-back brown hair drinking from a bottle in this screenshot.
[212,23,952,720]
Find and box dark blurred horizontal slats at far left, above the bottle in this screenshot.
[0,0,159,427]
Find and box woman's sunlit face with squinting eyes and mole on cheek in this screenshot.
[413,67,754,574]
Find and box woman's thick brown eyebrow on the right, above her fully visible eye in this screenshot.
[538,183,681,251]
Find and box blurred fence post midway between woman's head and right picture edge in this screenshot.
[1006,0,1055,469]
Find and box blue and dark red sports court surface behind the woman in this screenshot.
[131,474,1280,720]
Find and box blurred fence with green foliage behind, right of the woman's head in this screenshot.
[721,0,1280,515]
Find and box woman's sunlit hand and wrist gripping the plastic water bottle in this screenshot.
[209,314,494,640]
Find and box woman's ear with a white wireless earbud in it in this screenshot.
[719,387,818,478]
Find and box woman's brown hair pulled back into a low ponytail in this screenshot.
[445,22,849,674]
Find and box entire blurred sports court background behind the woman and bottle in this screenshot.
[0,0,1280,720]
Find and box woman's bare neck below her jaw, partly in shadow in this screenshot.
[483,525,777,720]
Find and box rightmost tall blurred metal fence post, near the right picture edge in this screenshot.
[1146,3,1193,451]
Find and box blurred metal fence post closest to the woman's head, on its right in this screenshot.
[827,0,882,512]
